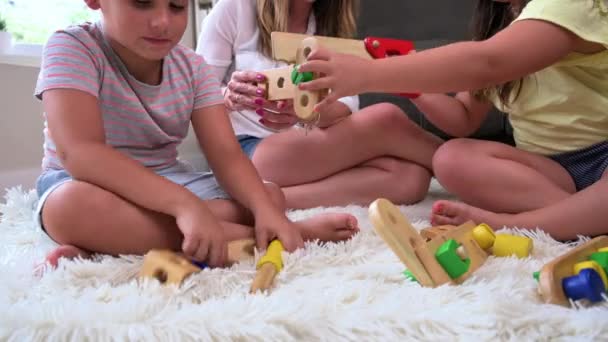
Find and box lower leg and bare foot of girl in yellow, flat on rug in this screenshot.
[433,174,608,240]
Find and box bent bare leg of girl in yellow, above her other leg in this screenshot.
[433,139,575,213]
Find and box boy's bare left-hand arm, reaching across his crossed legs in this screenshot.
[43,89,226,266]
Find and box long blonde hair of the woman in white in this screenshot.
[257,0,359,57]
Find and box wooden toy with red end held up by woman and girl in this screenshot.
[258,32,418,122]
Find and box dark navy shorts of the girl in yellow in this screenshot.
[549,141,608,191]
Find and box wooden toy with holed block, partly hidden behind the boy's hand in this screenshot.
[139,239,255,285]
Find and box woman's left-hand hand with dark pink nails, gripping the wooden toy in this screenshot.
[224,71,268,110]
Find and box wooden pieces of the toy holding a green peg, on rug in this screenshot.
[369,199,487,287]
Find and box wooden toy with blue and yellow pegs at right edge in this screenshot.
[538,236,608,306]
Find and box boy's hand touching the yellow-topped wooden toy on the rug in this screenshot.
[255,213,304,252]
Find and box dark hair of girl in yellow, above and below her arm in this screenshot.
[472,0,531,106]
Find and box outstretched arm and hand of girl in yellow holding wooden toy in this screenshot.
[300,20,579,110]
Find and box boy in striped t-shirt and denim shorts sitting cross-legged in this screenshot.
[35,0,358,266]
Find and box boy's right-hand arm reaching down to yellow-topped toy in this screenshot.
[192,105,304,251]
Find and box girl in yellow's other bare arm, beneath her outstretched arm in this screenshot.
[412,92,492,137]
